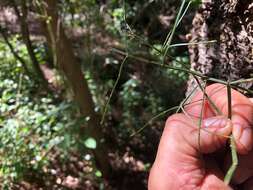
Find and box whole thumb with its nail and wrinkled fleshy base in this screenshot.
[148,114,232,190]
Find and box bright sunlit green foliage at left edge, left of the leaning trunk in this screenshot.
[0,41,88,187]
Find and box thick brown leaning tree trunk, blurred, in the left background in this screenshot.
[40,0,110,176]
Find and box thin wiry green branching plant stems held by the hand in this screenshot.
[101,0,253,184]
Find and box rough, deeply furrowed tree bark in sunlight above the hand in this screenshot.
[189,0,253,92]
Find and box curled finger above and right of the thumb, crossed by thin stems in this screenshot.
[185,84,253,154]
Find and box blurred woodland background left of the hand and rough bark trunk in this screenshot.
[0,0,202,190]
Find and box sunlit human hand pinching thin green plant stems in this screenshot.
[148,84,253,190]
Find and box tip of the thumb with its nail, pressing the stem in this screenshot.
[186,116,232,153]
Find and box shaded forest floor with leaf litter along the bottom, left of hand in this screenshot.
[13,124,160,190]
